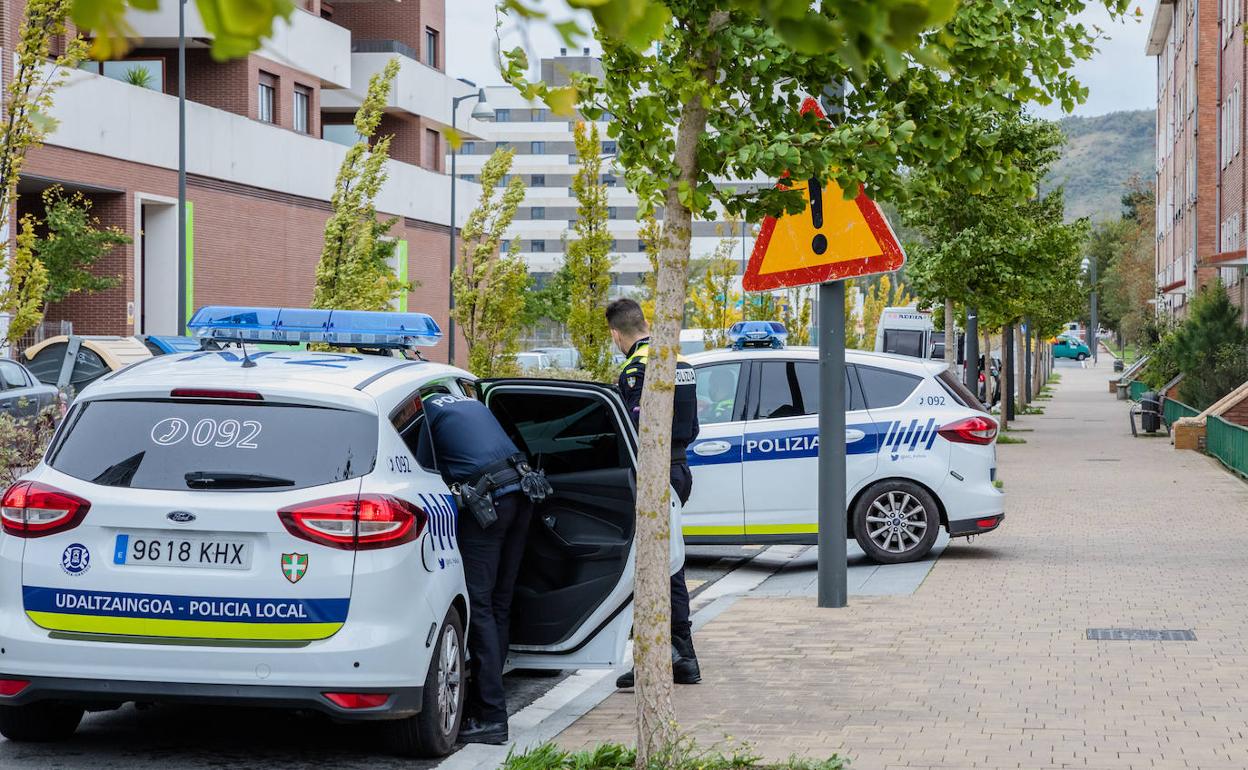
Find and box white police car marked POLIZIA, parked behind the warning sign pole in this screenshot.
[683,348,1005,563]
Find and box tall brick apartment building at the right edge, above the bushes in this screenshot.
[1147,0,1248,316]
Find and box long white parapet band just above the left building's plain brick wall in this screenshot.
[46,70,480,226]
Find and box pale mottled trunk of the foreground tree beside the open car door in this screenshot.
[633,79,706,768]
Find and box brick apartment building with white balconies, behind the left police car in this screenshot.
[0,0,479,359]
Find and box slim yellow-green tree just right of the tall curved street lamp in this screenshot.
[451,150,529,377]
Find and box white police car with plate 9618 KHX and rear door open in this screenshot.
[0,308,684,755]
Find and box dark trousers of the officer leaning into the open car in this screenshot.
[458,492,533,721]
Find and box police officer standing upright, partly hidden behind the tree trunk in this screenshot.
[607,300,701,688]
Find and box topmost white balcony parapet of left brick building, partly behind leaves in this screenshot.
[126,2,351,87]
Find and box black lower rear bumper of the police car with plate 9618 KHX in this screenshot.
[0,674,423,720]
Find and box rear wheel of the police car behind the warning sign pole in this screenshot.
[854,479,940,564]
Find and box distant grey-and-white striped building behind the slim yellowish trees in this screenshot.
[456,49,771,296]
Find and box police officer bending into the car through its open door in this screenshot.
[417,393,549,744]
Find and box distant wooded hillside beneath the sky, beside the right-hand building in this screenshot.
[1043,110,1156,220]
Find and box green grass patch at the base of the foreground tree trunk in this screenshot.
[502,741,849,770]
